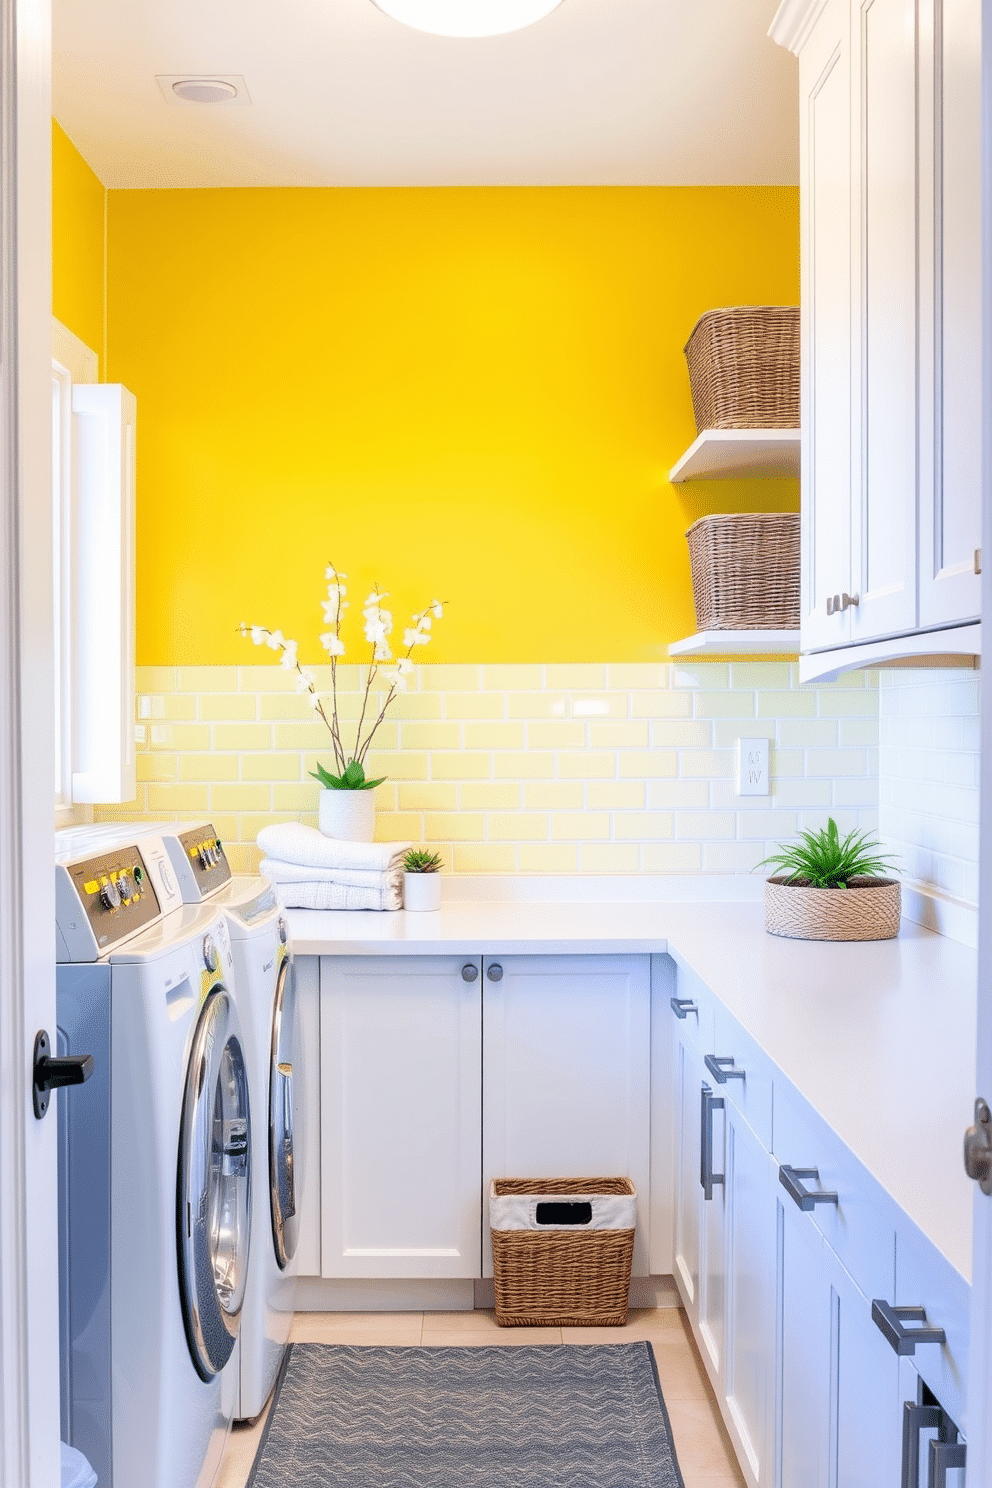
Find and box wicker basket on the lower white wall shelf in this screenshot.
[686,512,799,631]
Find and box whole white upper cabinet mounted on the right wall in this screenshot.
[772,0,982,676]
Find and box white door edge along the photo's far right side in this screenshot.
[967,0,992,1488]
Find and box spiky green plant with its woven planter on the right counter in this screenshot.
[764,817,901,940]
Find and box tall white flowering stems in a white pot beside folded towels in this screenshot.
[238,564,445,842]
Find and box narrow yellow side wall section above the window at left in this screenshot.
[52,119,107,357]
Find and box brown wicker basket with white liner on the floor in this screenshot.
[489,1178,637,1327]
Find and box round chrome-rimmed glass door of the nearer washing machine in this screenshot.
[177,982,251,1379]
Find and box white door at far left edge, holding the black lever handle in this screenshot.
[0,0,59,1488]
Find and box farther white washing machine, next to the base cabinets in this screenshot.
[63,821,303,1421]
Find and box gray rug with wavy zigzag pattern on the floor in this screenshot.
[248,1344,684,1488]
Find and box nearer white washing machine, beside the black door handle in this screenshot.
[55,829,253,1488]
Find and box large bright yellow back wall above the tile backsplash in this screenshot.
[107,187,799,665]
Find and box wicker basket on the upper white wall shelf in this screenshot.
[686,305,799,433]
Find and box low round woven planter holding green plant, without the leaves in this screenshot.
[764,875,901,940]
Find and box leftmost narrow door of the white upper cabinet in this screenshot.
[799,0,854,650]
